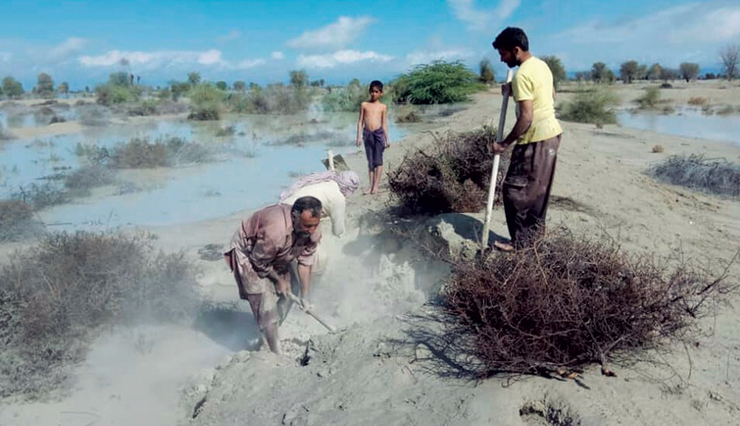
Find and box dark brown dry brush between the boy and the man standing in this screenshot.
[388,127,502,214]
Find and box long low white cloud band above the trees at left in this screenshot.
[79,50,228,69]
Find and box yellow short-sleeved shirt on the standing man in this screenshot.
[511,56,563,144]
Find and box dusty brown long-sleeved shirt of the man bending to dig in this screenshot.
[225,204,321,278]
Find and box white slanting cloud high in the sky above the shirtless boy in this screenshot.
[288,16,373,49]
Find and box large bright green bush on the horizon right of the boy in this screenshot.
[391,61,487,104]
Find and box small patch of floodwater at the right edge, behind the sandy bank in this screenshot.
[617,108,740,145]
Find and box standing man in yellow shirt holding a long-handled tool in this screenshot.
[493,27,563,251]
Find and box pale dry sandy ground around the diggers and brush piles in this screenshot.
[0,82,740,426]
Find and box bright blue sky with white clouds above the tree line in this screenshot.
[0,0,740,89]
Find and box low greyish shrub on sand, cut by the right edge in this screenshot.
[650,154,740,197]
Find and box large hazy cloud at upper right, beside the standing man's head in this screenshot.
[552,1,740,69]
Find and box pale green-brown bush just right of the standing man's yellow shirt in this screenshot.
[559,90,619,125]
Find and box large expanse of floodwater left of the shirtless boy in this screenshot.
[0,111,407,231]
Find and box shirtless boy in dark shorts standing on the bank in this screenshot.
[357,80,391,194]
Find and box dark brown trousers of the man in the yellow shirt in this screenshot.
[503,135,561,248]
